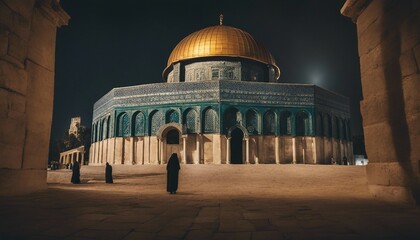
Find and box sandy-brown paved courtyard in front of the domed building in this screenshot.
[0,165,420,240]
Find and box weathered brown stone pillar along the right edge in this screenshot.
[341,0,420,203]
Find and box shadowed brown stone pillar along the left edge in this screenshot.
[0,0,69,195]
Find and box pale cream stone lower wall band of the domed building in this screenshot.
[89,134,353,165]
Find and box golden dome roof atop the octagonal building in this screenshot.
[163,25,280,79]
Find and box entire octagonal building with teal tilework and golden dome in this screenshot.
[89,18,353,165]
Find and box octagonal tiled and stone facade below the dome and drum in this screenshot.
[90,80,353,165]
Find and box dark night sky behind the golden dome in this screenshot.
[51,0,362,140]
